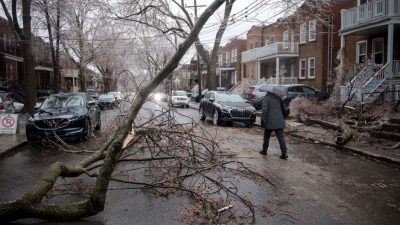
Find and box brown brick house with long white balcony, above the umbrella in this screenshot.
[242,0,345,91]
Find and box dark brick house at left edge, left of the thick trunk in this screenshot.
[0,17,24,82]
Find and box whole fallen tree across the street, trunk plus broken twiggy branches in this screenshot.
[0,0,262,223]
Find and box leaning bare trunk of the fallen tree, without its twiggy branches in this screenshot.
[0,0,223,222]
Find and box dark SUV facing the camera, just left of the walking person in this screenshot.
[199,91,256,126]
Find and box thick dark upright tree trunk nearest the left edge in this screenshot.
[21,0,36,113]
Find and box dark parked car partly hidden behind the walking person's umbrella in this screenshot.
[245,84,329,109]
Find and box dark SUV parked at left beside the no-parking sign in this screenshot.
[26,92,101,143]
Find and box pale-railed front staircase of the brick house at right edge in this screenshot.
[341,60,400,103]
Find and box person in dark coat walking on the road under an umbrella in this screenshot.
[260,86,288,159]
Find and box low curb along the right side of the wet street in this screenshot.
[289,134,400,166]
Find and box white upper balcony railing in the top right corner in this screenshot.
[342,0,400,30]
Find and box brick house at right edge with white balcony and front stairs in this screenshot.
[340,0,400,102]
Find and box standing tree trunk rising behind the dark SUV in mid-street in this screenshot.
[207,0,235,90]
